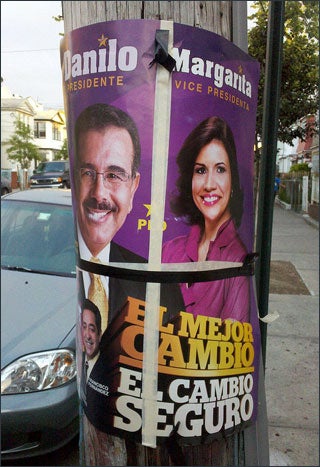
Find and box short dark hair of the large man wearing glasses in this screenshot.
[74,104,141,176]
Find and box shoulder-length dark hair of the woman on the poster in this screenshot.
[170,117,243,227]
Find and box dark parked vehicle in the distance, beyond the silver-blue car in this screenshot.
[30,161,70,188]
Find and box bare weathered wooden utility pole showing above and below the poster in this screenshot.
[61,1,267,466]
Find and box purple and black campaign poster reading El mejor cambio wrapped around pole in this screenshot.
[61,20,260,447]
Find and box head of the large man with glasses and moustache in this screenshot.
[74,104,140,262]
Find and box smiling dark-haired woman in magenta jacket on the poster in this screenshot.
[162,117,249,321]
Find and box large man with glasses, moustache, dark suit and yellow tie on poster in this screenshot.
[73,104,145,334]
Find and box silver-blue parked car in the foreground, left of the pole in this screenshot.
[1,189,79,460]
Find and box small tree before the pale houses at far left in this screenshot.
[6,120,41,169]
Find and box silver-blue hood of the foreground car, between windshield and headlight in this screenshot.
[1,270,77,368]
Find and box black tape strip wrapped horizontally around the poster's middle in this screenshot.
[78,253,258,284]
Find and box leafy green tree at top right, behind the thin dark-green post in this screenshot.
[248,0,319,145]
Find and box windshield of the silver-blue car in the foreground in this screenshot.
[1,199,76,277]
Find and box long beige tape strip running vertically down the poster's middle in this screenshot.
[142,21,173,447]
